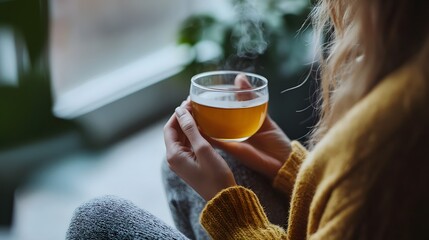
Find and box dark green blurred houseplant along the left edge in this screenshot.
[0,0,72,227]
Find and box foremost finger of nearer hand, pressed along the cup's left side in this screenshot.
[176,107,207,148]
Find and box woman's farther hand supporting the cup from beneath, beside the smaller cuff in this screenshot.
[210,116,292,180]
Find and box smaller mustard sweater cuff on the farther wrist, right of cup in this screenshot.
[273,141,308,195]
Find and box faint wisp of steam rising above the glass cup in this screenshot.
[232,0,268,59]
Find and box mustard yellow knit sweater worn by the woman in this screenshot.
[200,62,429,240]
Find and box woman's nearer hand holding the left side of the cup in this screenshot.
[164,101,236,201]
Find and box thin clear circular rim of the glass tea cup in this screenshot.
[191,70,268,93]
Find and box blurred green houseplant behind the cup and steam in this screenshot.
[178,0,315,141]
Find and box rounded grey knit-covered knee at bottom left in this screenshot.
[66,196,187,240]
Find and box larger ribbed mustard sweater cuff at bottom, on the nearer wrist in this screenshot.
[200,186,269,239]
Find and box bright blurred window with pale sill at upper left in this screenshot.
[50,0,231,118]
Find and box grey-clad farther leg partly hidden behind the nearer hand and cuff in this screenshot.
[162,150,289,240]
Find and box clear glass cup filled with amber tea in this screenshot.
[190,71,268,142]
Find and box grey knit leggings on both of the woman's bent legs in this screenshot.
[66,151,289,240]
